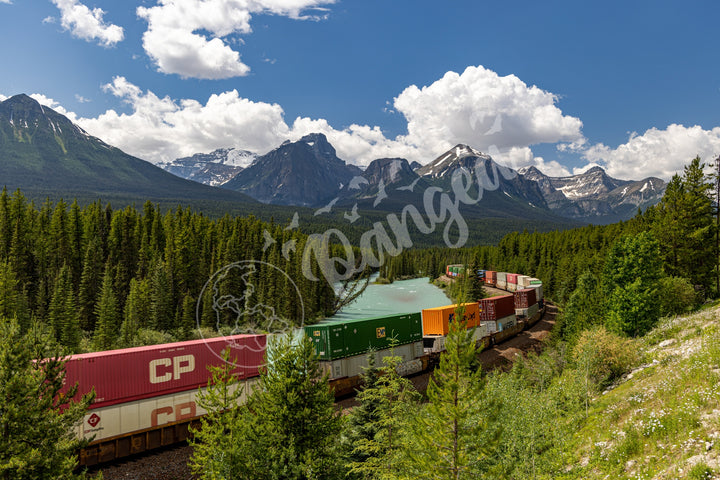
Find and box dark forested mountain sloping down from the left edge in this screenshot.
[0,94,257,207]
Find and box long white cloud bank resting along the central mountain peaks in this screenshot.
[39,65,584,167]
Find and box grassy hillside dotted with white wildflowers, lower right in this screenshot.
[564,304,720,479]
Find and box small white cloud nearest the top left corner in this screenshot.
[52,0,125,47]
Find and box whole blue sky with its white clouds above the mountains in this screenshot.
[0,0,720,179]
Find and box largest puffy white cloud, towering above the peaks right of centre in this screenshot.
[394,66,584,159]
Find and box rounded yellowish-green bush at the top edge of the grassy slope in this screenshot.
[573,327,639,389]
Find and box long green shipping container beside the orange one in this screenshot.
[305,312,422,360]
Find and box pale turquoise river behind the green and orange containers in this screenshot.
[327,277,452,321]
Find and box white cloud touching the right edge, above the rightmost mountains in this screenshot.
[584,124,720,180]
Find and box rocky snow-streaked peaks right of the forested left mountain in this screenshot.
[173,133,665,223]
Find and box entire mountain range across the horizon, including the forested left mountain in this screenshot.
[0,95,665,228]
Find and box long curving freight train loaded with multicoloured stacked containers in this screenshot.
[65,266,544,466]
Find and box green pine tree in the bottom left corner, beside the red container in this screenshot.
[0,318,94,480]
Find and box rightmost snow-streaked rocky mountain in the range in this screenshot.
[520,163,666,221]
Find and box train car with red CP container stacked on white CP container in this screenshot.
[64,335,266,465]
